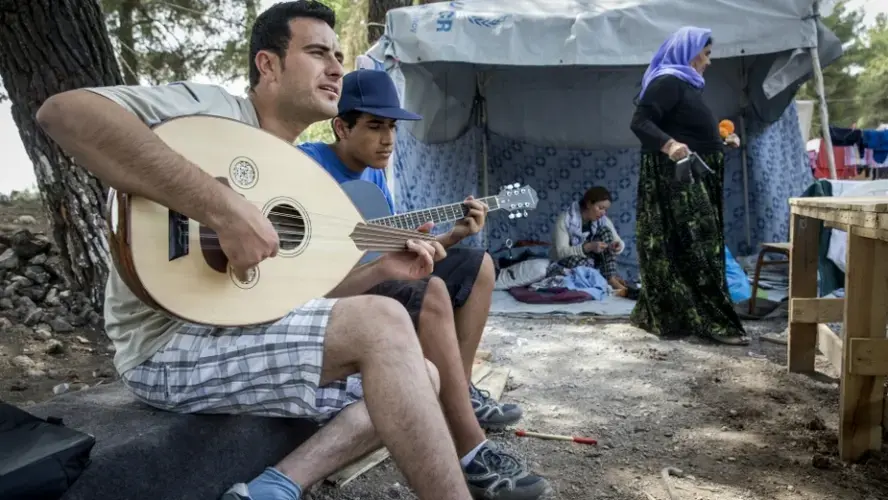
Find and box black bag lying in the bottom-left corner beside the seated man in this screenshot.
[0,401,96,500]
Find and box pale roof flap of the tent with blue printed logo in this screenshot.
[386,0,832,66]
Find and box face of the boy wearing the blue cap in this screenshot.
[339,113,396,169]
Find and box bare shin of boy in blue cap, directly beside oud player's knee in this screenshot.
[418,276,485,457]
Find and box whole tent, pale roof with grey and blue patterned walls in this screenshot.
[362,0,842,258]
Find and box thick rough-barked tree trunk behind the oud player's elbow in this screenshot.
[0,0,123,313]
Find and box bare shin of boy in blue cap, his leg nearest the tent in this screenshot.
[454,253,496,380]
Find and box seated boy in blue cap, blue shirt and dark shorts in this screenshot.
[299,70,547,499]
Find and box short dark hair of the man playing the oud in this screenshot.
[250,0,336,88]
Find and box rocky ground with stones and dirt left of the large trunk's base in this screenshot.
[0,197,114,403]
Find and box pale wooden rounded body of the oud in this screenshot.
[107,116,372,327]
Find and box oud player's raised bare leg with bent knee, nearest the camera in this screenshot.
[321,296,470,500]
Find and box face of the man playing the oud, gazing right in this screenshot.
[269,18,344,123]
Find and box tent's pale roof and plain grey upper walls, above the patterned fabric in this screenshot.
[370,0,841,147]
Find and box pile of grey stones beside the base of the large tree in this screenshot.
[0,229,102,333]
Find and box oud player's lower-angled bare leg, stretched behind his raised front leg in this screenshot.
[275,361,441,490]
